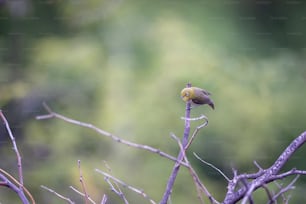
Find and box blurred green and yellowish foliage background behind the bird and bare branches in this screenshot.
[0,0,306,204]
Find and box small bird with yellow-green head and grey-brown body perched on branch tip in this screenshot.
[181,87,215,109]
